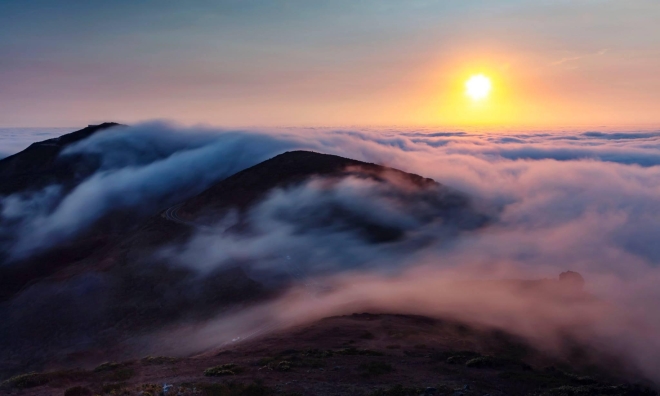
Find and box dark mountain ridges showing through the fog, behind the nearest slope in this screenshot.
[0,135,487,378]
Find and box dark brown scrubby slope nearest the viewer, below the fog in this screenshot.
[0,313,656,396]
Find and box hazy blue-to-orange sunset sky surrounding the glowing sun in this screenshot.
[0,0,660,128]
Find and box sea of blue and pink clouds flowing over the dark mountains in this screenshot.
[0,123,660,380]
